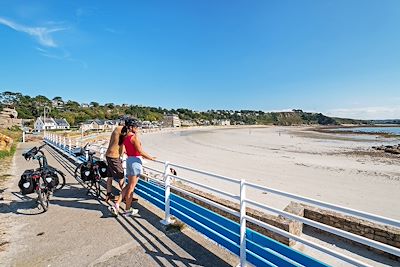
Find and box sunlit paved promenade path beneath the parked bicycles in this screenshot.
[0,143,238,266]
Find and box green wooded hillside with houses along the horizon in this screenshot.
[0,91,362,125]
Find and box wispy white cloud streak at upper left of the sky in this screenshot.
[0,17,66,47]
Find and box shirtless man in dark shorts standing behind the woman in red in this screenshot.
[106,121,124,201]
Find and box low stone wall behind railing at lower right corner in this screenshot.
[302,204,400,260]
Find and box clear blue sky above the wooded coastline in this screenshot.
[0,0,400,118]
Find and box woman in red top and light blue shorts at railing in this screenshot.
[111,119,155,216]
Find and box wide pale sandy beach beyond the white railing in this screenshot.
[138,126,400,219]
